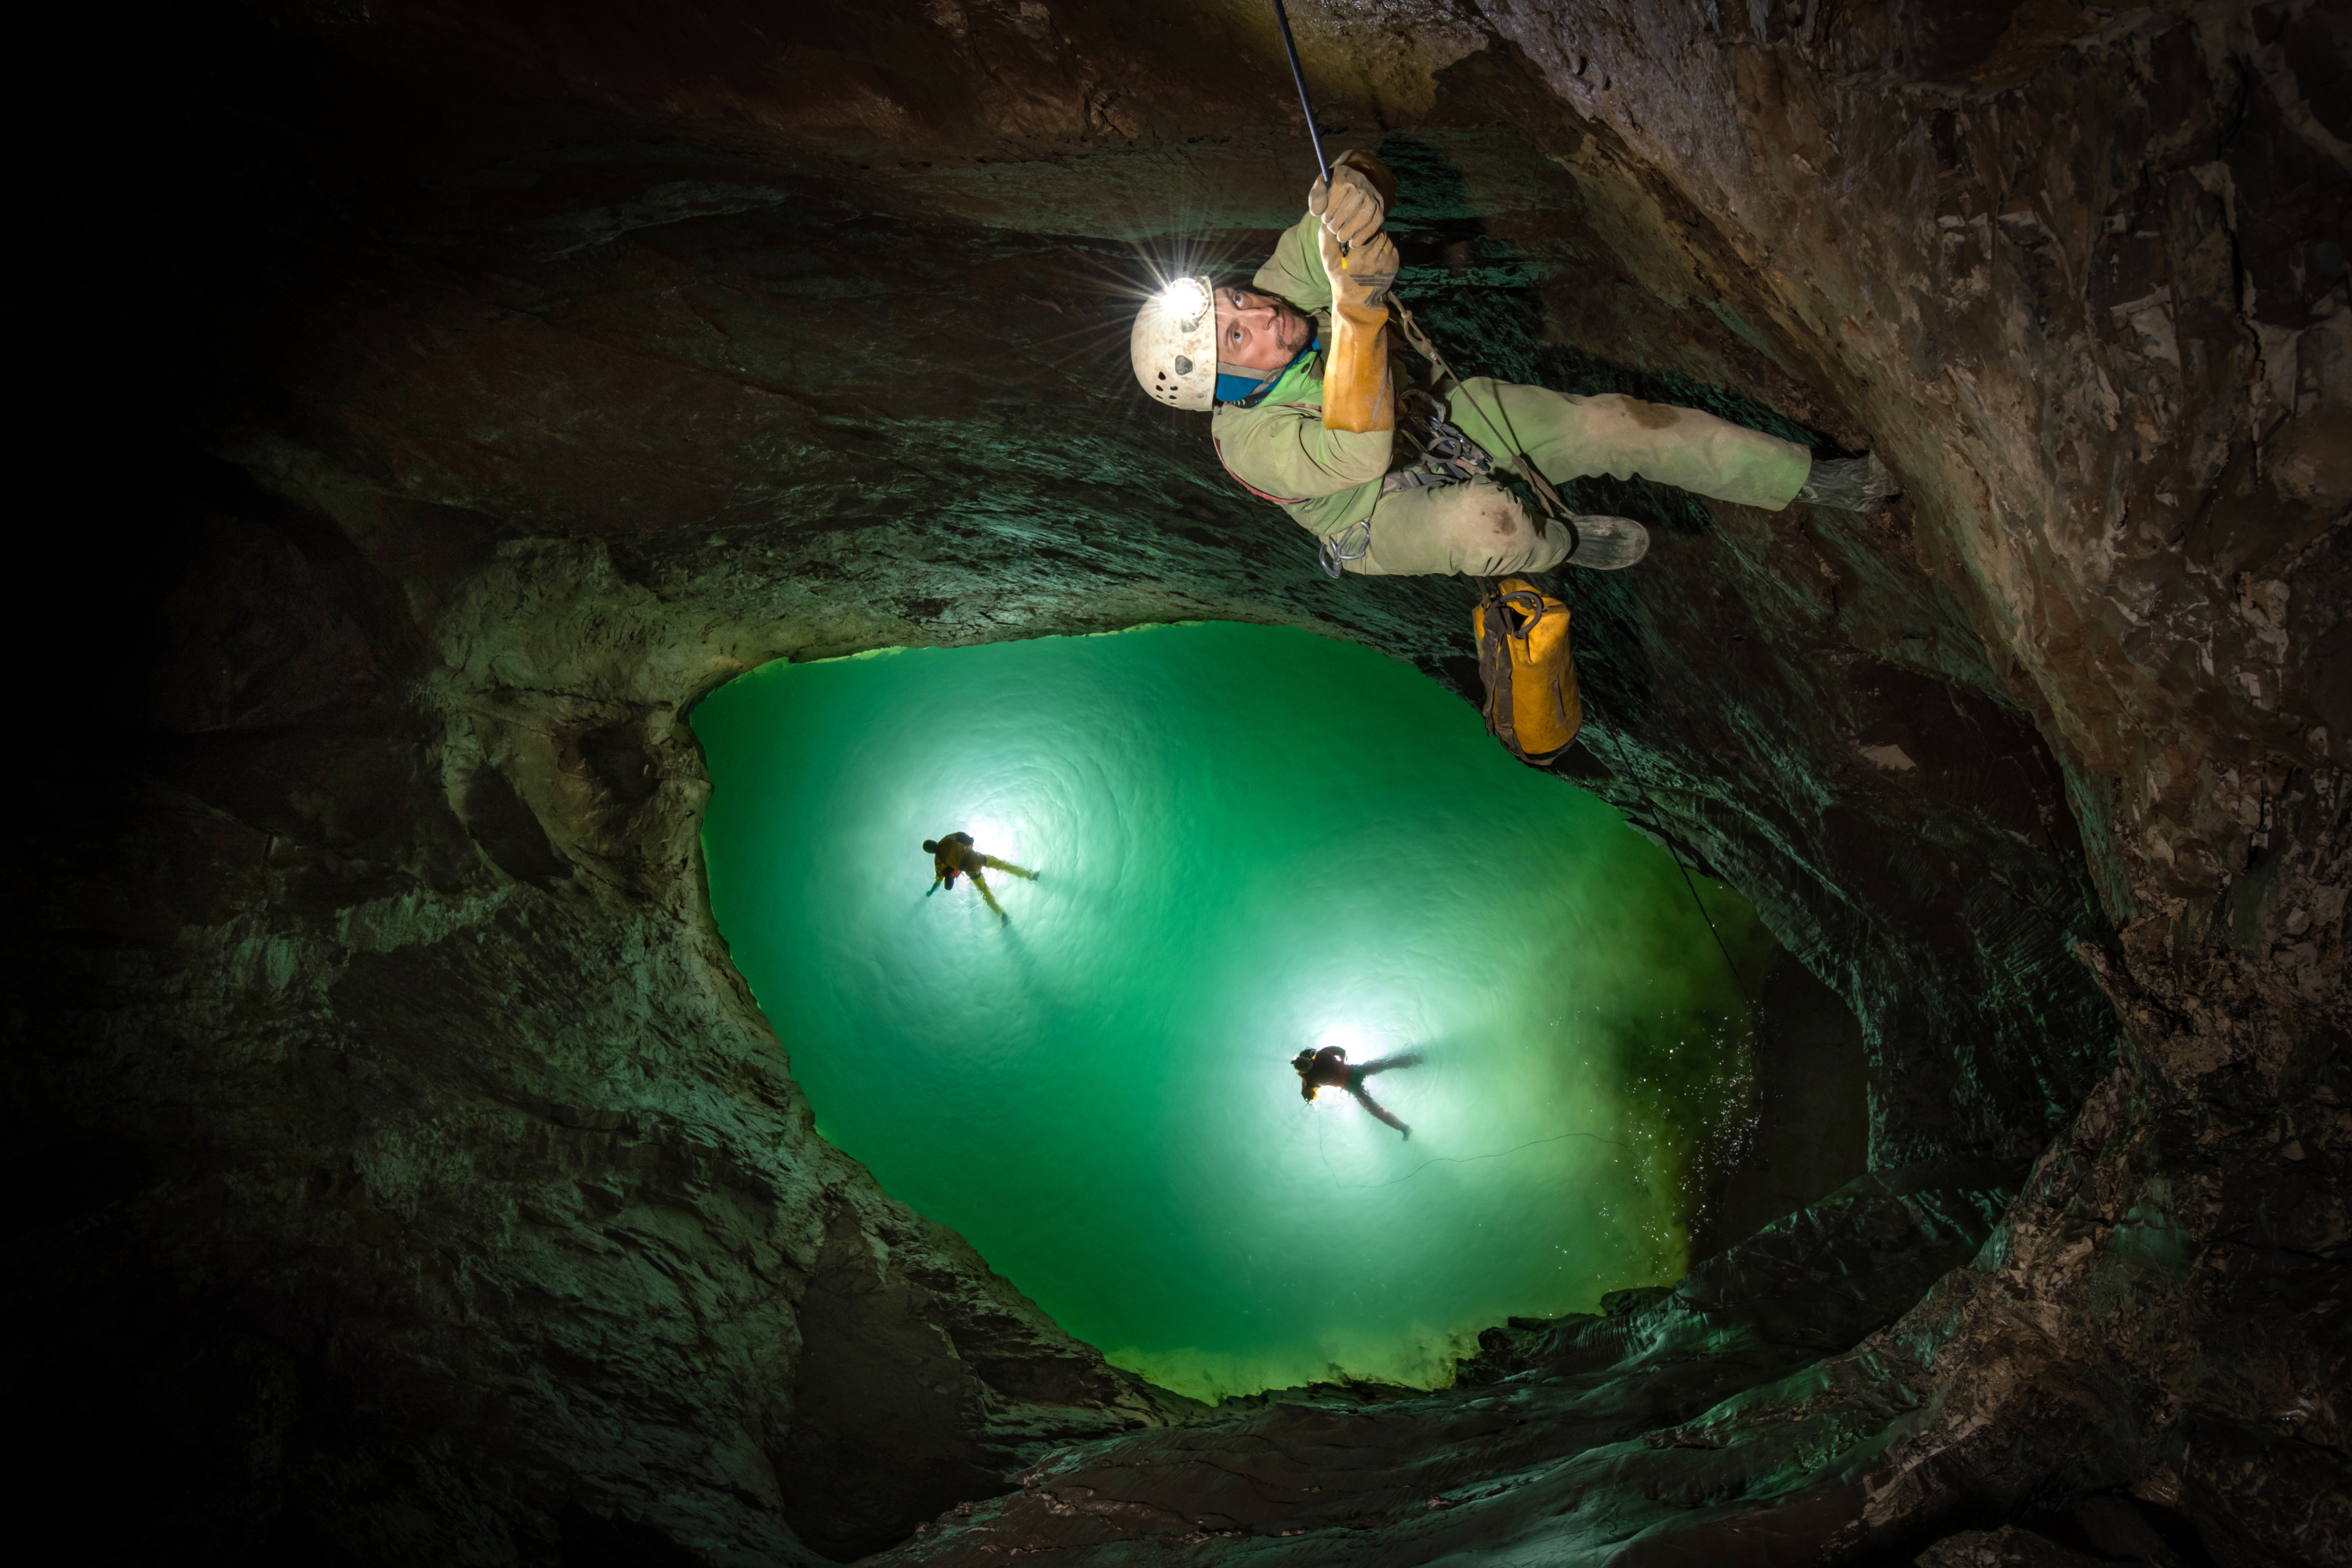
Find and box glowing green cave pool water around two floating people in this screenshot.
[694,623,1771,1396]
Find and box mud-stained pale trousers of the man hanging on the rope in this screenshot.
[1348,376,1813,576]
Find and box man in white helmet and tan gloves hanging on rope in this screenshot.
[1131,0,1893,576]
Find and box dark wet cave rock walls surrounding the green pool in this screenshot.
[9,0,2352,1563]
